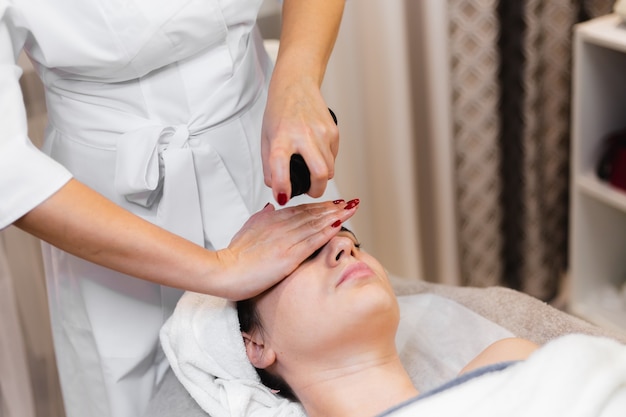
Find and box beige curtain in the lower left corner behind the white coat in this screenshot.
[0,227,65,417]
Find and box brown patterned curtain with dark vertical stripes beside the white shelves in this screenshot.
[448,0,613,300]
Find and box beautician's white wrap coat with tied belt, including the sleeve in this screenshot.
[0,0,337,417]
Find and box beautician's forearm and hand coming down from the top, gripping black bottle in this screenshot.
[262,0,345,203]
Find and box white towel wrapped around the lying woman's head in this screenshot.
[160,292,305,417]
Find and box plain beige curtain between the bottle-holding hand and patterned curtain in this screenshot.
[324,0,459,284]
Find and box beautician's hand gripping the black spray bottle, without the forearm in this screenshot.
[261,78,339,204]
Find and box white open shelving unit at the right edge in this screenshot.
[569,15,626,332]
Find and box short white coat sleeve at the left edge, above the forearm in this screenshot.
[0,0,71,229]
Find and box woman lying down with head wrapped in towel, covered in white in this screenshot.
[161,229,626,417]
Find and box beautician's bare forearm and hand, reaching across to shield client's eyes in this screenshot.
[15,180,355,300]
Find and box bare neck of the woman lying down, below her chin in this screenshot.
[296,355,418,417]
